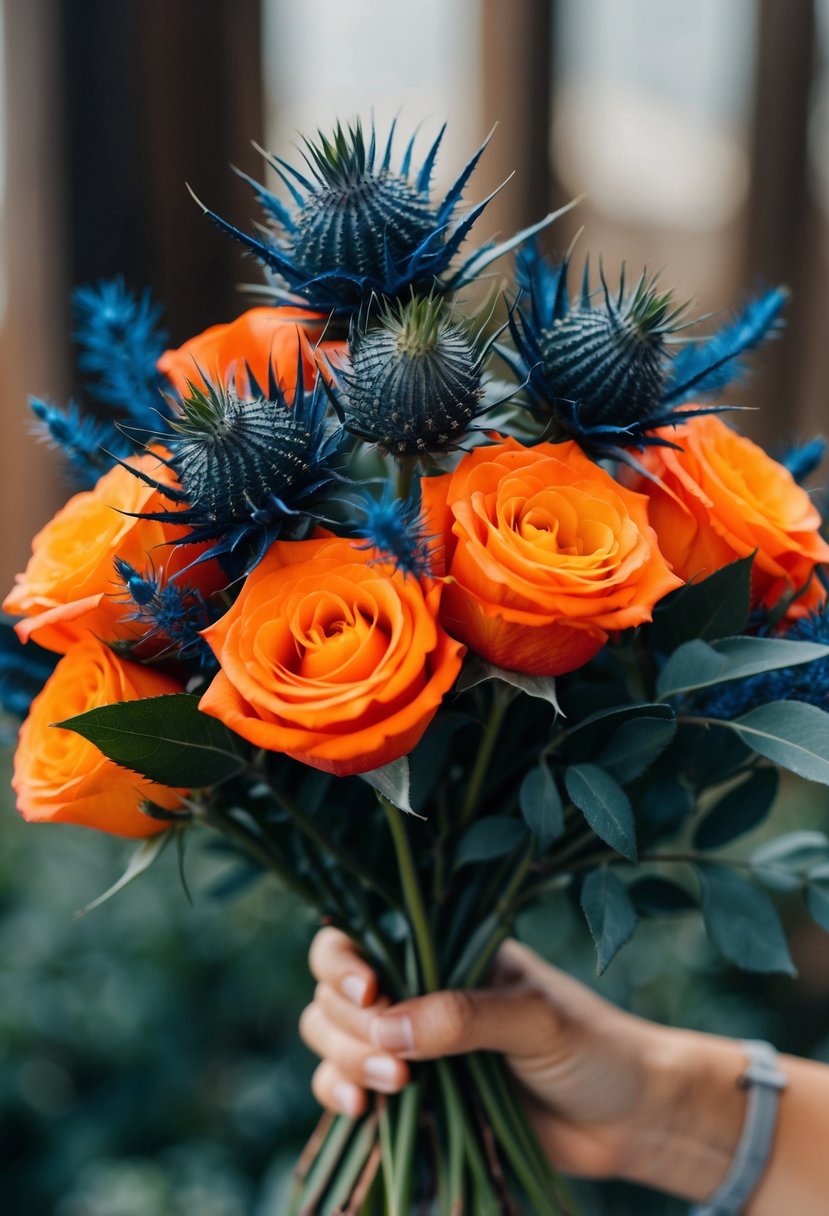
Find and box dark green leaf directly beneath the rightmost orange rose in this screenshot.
[650,553,754,654]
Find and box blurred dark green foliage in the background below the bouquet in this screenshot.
[0,734,829,1216]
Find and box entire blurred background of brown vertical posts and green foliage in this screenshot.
[0,0,829,1216]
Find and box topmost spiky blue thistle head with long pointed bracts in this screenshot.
[188,119,562,316]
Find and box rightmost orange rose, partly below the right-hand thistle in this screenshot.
[631,415,829,617]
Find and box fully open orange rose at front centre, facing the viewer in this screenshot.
[199,537,463,776]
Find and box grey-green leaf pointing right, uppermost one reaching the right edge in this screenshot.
[656,637,829,698]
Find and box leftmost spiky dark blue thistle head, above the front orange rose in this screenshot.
[125,355,339,573]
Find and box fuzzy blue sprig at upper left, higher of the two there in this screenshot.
[73,278,167,430]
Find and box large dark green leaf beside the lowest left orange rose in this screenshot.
[56,693,244,789]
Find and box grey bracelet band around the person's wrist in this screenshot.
[689,1041,789,1216]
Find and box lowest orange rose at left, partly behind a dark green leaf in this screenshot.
[12,637,182,837]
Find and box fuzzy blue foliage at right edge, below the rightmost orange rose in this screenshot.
[705,608,829,720]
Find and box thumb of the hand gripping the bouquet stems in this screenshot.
[370,987,562,1060]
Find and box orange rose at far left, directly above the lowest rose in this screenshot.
[2,456,221,654]
